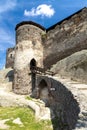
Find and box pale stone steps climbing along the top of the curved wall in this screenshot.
[54,75,87,130]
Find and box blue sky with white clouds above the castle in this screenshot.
[0,0,87,69]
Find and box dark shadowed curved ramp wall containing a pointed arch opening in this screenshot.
[36,76,80,130]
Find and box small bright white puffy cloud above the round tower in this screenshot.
[24,4,55,18]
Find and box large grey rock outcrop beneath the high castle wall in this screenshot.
[51,50,87,83]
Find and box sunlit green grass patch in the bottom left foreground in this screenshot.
[0,107,52,130]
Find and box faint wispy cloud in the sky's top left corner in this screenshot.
[0,0,17,13]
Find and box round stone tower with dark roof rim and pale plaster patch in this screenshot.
[13,21,45,94]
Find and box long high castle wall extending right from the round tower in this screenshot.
[44,8,87,68]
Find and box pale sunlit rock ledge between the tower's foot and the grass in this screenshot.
[0,69,50,121]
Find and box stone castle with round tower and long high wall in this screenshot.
[6,8,87,94]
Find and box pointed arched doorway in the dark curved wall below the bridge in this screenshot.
[38,79,49,103]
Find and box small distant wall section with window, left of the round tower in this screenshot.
[5,48,15,68]
